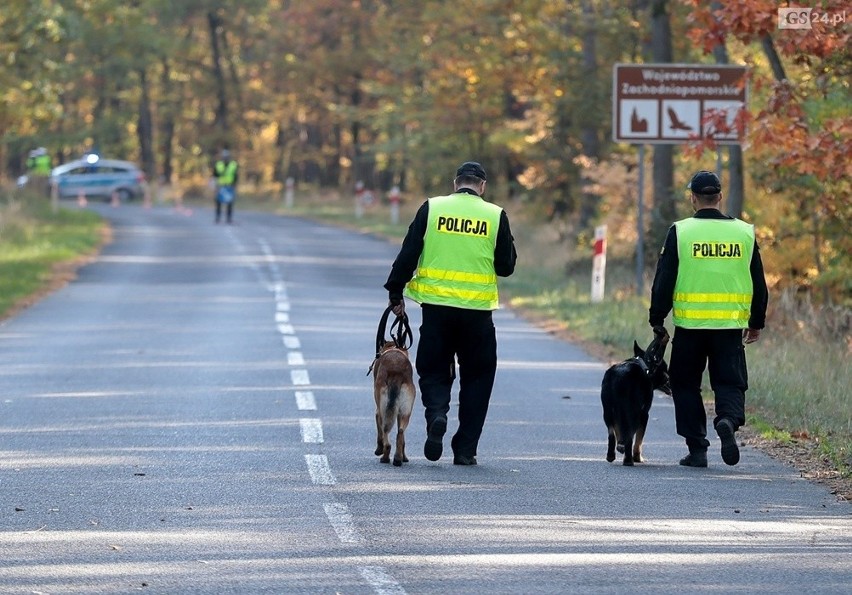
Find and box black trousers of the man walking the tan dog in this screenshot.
[416,304,497,456]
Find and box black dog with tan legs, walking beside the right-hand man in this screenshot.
[601,328,672,466]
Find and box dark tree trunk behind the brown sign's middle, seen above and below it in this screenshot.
[646,0,677,255]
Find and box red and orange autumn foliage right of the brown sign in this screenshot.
[689,0,852,302]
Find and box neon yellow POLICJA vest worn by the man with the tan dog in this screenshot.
[405,193,503,310]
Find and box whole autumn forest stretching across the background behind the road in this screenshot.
[0,0,852,304]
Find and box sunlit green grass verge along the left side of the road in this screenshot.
[0,191,105,319]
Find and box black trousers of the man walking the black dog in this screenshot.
[669,327,748,450]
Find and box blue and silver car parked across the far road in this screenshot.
[50,154,145,201]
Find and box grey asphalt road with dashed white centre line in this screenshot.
[0,205,852,594]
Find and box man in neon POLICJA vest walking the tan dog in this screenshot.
[384,162,517,465]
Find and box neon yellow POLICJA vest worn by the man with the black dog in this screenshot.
[672,217,754,329]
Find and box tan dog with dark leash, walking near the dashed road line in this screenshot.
[367,307,417,467]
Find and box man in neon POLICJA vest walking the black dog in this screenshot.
[648,171,769,467]
